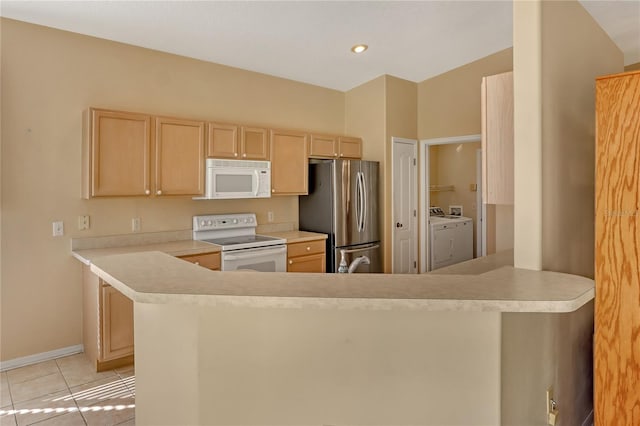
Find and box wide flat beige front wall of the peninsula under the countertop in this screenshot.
[134,302,500,426]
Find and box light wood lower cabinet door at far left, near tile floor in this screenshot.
[100,284,133,361]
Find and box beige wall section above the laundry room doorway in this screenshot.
[418,49,513,139]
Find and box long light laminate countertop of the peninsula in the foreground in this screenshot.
[91,251,594,312]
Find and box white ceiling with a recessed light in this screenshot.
[0,0,640,91]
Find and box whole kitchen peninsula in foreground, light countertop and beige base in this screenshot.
[81,251,594,425]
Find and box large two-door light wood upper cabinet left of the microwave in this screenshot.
[83,108,205,198]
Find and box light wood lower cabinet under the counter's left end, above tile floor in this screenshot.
[82,266,133,371]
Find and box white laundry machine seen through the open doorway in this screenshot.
[429,207,473,270]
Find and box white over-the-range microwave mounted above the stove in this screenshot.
[194,158,271,200]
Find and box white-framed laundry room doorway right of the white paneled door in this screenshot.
[419,134,487,272]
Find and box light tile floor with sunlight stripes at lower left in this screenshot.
[0,354,136,426]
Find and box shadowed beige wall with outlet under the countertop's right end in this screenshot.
[501,302,593,426]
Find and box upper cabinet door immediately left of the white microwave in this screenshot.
[155,117,204,195]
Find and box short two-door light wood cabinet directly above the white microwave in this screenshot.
[207,123,269,160]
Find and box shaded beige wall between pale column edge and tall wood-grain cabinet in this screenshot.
[541,1,624,277]
